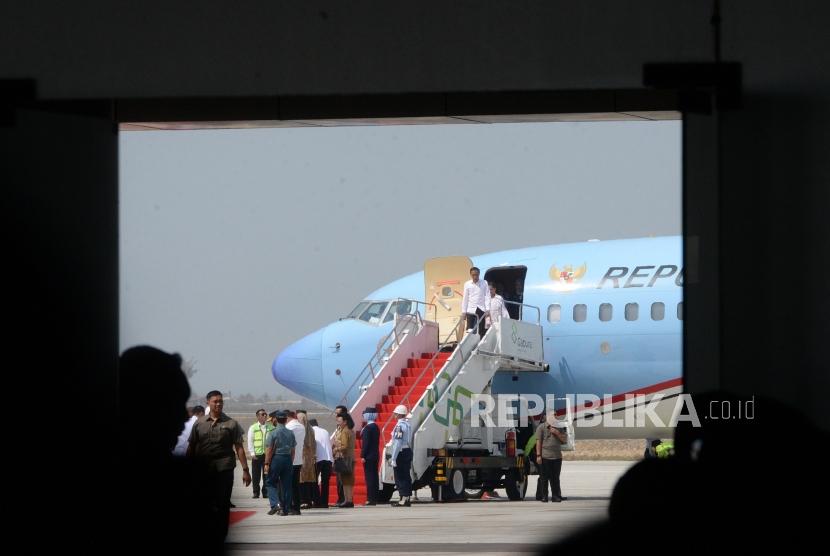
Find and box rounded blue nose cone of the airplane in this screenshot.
[271,329,323,401]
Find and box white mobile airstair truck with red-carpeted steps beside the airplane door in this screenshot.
[332,300,547,504]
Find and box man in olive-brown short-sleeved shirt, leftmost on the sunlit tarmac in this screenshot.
[187,390,251,538]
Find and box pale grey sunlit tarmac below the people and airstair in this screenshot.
[227,461,636,556]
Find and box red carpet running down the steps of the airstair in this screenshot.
[329,352,452,506]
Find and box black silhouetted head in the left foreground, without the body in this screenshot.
[118,346,190,459]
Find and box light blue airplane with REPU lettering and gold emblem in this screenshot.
[272,236,683,439]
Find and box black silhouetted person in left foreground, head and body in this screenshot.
[119,346,224,554]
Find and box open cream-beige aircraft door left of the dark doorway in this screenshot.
[424,257,473,342]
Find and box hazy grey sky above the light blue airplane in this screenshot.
[120,121,681,396]
